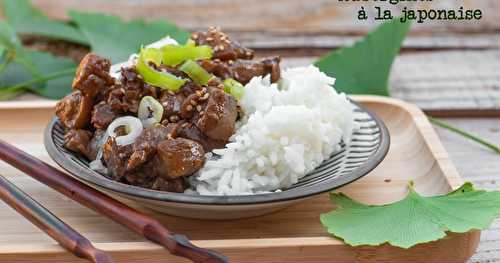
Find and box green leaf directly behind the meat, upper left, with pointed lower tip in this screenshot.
[69,11,189,63]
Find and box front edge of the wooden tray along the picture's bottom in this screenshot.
[0,233,480,263]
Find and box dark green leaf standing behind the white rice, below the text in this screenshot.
[314,18,410,96]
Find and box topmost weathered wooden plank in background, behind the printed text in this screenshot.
[3,0,494,52]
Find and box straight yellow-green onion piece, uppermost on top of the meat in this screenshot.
[161,40,212,66]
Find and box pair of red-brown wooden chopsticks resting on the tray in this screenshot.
[0,140,230,263]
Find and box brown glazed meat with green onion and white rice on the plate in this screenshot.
[56,28,356,195]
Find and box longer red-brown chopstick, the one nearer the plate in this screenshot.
[0,140,231,263]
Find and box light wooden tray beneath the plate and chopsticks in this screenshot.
[0,96,480,263]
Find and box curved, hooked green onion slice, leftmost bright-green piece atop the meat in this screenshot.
[136,48,186,91]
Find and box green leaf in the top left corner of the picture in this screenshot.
[3,0,88,44]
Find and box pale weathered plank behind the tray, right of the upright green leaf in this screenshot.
[283,50,500,116]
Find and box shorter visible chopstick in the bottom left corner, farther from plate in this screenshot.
[0,175,113,263]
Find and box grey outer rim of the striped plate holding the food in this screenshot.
[44,100,390,206]
